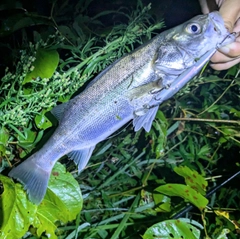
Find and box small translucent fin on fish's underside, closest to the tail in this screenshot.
[68,145,95,173]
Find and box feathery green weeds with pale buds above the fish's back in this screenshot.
[0,0,162,171]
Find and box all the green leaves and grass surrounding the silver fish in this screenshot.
[0,0,240,239]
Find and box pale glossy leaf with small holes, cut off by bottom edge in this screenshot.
[143,220,200,239]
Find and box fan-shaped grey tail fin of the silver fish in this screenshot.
[8,157,51,205]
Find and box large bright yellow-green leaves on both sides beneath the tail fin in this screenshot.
[0,163,82,239]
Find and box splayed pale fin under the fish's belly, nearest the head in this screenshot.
[133,106,158,132]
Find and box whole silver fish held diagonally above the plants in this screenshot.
[9,12,232,205]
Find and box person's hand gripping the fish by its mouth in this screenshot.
[199,0,240,70]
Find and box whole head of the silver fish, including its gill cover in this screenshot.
[154,12,234,76]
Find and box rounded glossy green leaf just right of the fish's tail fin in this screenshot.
[33,163,83,239]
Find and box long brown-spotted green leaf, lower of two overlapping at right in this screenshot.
[155,183,208,210]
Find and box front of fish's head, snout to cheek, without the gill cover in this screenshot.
[168,12,233,58]
